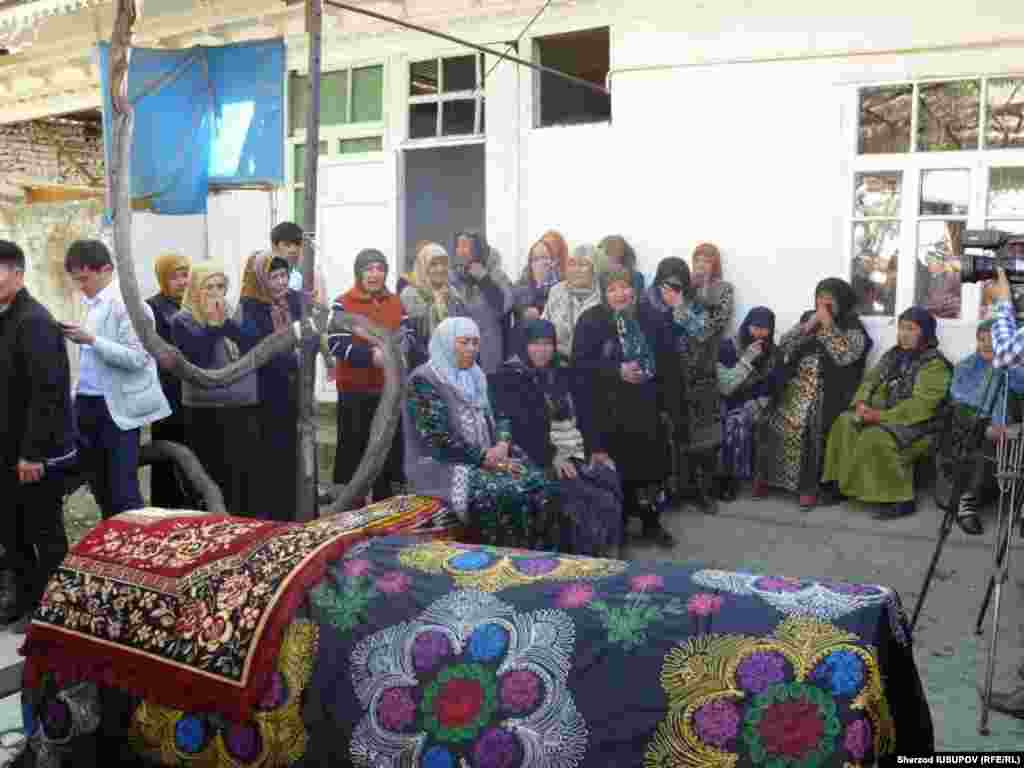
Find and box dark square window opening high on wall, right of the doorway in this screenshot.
[536,27,611,128]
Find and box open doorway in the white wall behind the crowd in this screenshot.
[403,143,484,270]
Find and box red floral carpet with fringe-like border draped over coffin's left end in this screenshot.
[22,497,454,721]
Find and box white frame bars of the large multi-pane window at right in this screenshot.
[843,72,1024,327]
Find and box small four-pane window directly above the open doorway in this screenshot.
[409,53,484,139]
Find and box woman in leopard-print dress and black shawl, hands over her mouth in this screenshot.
[754,278,871,510]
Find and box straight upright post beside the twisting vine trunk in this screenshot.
[295,0,323,520]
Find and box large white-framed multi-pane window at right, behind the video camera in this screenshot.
[849,77,1024,322]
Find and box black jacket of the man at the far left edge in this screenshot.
[0,288,75,469]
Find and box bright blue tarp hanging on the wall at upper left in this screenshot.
[99,40,285,215]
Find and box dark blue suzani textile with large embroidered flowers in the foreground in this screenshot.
[18,536,935,768]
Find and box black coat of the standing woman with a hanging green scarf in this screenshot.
[572,302,686,456]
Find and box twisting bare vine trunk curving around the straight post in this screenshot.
[110,0,404,520]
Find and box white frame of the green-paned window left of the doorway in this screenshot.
[284,58,390,222]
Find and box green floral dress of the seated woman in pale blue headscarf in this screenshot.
[407,376,557,549]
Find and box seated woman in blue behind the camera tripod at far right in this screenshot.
[948,321,1024,536]
